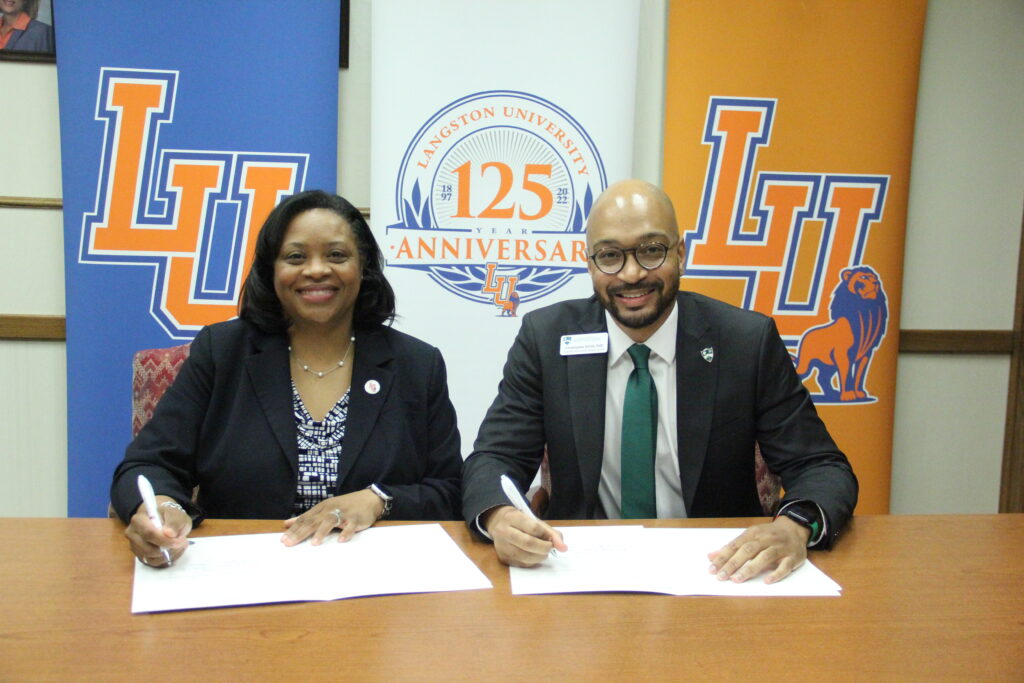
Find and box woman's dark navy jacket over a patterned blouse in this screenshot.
[111,319,462,521]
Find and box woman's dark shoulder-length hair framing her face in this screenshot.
[239,189,394,333]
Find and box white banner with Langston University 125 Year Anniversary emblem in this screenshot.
[371,0,639,455]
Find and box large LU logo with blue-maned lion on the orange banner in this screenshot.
[684,97,890,403]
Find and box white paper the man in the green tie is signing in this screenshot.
[510,526,841,596]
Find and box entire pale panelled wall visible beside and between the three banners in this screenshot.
[0,0,1024,516]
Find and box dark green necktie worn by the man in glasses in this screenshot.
[622,344,657,519]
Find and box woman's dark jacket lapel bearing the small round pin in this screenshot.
[338,330,394,487]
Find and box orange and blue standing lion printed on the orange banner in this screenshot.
[797,265,889,401]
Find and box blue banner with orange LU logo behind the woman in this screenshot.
[55,0,340,516]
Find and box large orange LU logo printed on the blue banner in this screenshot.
[79,68,308,339]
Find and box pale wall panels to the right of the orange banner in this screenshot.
[890,0,1024,513]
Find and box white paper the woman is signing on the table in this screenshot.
[132,524,490,612]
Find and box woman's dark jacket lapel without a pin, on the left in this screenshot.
[245,332,299,474]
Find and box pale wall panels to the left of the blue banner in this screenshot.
[0,61,68,517]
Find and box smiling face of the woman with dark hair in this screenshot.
[273,209,362,335]
